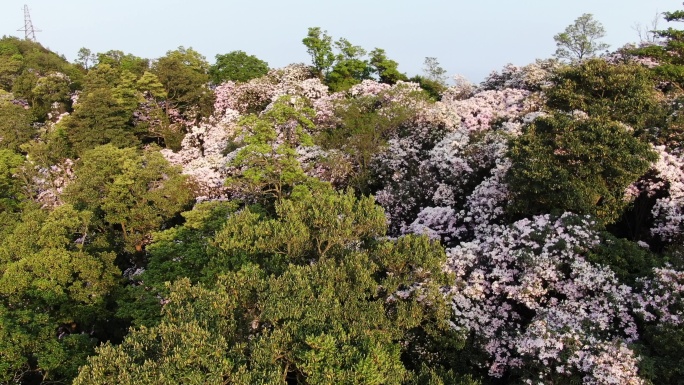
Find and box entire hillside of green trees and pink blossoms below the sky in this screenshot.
[0,11,684,385]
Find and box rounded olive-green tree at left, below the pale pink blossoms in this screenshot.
[64,145,193,252]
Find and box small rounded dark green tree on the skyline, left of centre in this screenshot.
[209,51,268,84]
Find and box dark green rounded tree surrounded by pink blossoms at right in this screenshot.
[508,113,656,224]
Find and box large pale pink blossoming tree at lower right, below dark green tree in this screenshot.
[447,214,641,384]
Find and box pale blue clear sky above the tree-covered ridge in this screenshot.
[0,0,684,83]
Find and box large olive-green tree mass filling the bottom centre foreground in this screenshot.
[75,187,463,384]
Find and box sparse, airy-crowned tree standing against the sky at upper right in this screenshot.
[553,13,609,62]
